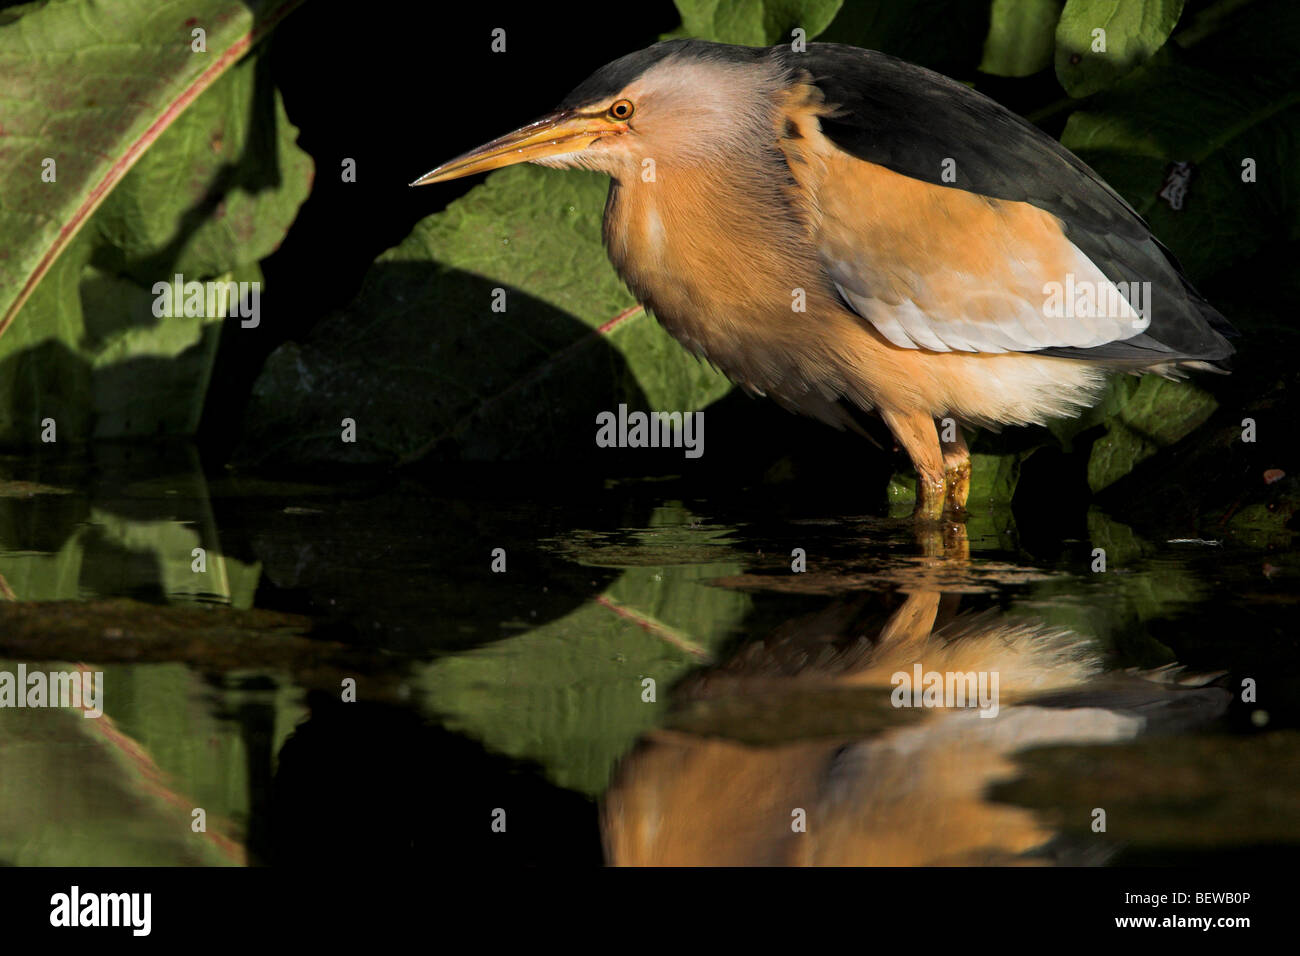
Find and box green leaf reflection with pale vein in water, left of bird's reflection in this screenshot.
[417,507,750,796]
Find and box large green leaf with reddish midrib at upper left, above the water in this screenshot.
[0,4,312,444]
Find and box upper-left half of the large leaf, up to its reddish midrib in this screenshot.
[0,0,298,333]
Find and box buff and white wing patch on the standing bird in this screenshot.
[811,152,1152,352]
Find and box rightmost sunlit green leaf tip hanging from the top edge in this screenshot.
[1056,0,1183,98]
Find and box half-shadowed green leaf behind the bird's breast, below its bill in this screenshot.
[242,166,731,462]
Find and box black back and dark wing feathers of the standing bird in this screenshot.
[772,43,1235,364]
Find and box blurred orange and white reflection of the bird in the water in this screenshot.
[602,589,1229,866]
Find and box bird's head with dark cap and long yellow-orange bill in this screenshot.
[411,40,787,186]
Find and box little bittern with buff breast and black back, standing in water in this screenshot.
[413,40,1234,518]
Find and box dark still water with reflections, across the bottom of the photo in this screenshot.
[0,447,1300,865]
